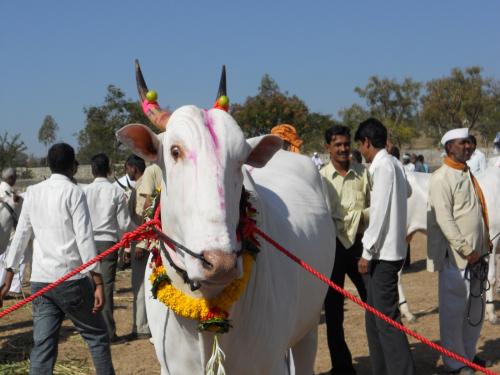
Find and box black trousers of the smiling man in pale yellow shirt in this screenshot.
[325,236,366,374]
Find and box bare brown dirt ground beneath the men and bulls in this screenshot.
[0,234,500,375]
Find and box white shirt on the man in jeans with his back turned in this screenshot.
[5,174,100,283]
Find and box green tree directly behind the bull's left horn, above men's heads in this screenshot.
[77,85,154,162]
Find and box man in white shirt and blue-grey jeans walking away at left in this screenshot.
[0,143,114,375]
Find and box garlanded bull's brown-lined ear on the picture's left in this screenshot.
[116,124,161,161]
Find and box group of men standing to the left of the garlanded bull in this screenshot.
[0,143,161,374]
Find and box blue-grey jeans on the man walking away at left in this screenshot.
[30,277,115,375]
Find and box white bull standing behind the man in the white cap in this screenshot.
[398,167,500,324]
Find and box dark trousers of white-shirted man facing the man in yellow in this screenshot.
[365,260,415,375]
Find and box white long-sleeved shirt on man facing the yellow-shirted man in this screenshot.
[362,149,409,261]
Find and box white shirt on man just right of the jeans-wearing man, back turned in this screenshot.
[83,177,130,242]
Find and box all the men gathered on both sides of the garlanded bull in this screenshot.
[0,118,490,375]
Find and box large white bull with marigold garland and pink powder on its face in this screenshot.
[117,63,335,375]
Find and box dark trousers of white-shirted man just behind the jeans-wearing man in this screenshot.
[95,241,118,339]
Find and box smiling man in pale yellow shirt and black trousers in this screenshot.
[320,125,370,374]
